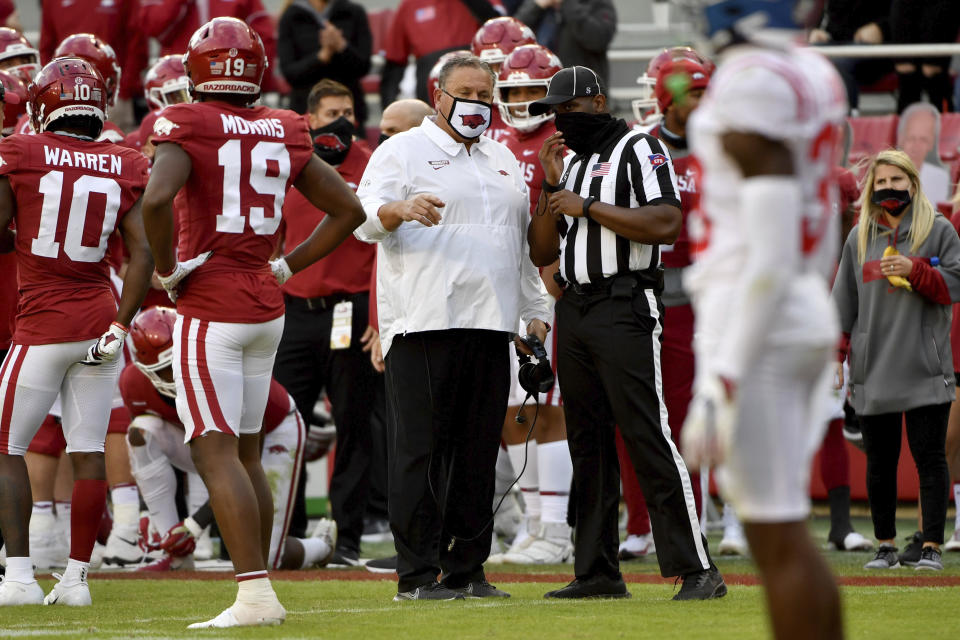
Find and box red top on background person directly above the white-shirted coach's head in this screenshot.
[384,0,500,64]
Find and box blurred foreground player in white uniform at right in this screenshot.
[682,0,847,639]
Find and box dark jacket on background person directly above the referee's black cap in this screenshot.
[514,0,617,82]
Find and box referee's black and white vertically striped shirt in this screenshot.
[558,130,680,284]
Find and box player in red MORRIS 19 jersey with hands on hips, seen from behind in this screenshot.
[143,18,365,628]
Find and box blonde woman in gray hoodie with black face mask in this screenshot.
[833,150,960,570]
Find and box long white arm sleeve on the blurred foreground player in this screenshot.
[713,176,803,381]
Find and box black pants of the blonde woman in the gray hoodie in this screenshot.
[859,404,950,544]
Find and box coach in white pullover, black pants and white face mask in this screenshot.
[355,56,550,600]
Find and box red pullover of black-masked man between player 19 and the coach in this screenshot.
[283,140,377,298]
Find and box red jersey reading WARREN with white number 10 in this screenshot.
[0,132,148,345]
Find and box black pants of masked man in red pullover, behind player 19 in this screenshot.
[273,292,385,552]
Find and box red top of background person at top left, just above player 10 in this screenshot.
[39,0,147,98]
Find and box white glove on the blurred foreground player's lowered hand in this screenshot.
[680,376,737,469]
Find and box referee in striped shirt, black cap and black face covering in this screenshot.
[527,66,726,600]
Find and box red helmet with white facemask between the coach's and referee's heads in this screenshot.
[495,44,563,131]
